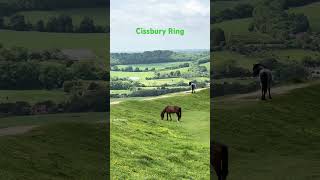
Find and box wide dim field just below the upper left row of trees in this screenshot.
[0,30,109,50]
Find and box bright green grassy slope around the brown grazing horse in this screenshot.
[111,90,210,179]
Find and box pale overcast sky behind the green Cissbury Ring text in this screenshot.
[110,0,210,52]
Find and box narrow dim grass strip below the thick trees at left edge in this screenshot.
[0,90,68,104]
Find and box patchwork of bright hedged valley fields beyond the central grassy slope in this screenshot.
[110,52,210,98]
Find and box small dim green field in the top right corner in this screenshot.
[289,2,320,32]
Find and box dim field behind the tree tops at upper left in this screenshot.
[19,8,109,26]
